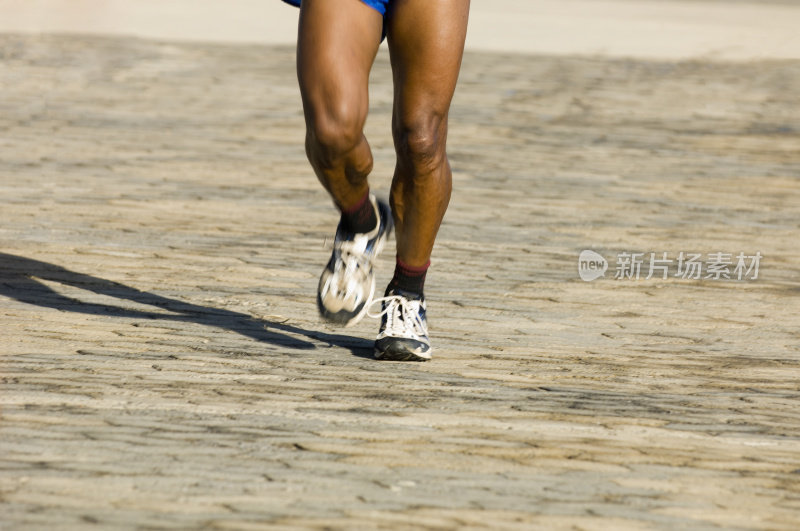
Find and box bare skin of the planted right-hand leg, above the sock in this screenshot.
[387,0,469,268]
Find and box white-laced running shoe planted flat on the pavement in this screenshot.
[369,290,432,361]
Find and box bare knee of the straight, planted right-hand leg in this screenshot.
[394,113,447,174]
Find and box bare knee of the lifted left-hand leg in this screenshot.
[306,103,366,160]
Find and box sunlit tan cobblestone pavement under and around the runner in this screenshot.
[0,35,800,530]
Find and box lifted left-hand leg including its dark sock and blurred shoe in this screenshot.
[297,0,392,326]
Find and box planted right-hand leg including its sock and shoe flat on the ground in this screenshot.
[373,0,469,361]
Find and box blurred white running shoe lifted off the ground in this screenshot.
[317,195,392,326]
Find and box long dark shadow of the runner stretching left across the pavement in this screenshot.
[0,253,372,358]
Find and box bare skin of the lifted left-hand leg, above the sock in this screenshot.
[297,0,383,210]
